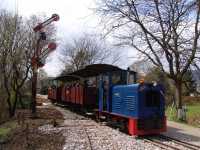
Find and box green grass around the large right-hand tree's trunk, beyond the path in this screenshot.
[166,103,200,127]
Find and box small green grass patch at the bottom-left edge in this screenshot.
[0,121,17,141]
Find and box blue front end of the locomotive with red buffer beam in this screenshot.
[137,84,166,130]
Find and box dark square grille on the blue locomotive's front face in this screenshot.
[145,91,160,107]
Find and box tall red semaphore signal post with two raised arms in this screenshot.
[31,14,59,115]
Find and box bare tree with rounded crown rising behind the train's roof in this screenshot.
[61,35,110,72]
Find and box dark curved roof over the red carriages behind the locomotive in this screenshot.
[54,64,134,81]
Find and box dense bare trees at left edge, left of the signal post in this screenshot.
[0,11,56,117]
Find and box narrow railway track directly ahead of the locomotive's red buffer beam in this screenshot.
[144,135,200,150]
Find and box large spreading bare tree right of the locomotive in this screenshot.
[96,0,200,119]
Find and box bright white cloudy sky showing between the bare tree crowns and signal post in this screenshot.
[0,0,136,76]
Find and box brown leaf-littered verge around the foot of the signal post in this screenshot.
[0,108,65,150]
